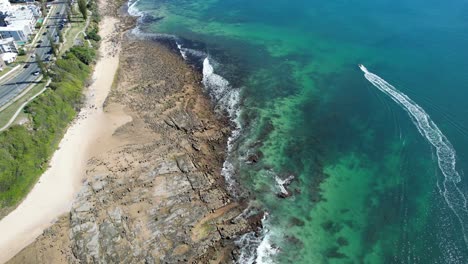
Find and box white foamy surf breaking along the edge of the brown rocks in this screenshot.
[128,0,270,264]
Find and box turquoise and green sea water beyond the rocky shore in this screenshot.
[130,0,468,263]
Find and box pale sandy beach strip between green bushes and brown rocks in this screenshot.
[0,16,131,263]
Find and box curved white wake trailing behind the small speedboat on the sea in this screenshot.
[359,65,468,250]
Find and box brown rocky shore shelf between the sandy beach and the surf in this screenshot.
[9,1,262,263]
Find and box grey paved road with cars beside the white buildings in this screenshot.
[0,0,67,107]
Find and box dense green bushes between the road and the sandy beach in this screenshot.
[0,47,96,207]
